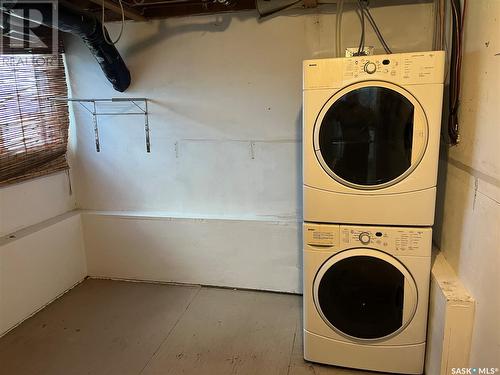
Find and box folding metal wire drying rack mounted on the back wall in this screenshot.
[49,98,151,152]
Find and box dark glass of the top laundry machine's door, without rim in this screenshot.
[318,86,414,186]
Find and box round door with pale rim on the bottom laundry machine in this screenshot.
[313,249,417,340]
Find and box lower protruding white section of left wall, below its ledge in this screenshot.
[0,213,87,336]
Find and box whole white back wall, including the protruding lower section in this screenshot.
[66,2,433,291]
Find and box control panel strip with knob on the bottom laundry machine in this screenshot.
[304,223,432,256]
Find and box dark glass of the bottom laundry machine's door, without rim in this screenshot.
[317,256,405,339]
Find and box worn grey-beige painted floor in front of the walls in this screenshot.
[0,280,380,375]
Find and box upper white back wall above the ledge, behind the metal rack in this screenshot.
[67,3,433,217]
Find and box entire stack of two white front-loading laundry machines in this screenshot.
[303,51,445,374]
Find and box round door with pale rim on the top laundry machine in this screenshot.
[313,81,428,190]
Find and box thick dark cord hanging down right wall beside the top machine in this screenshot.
[448,0,467,145]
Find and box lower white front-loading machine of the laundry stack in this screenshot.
[304,223,432,374]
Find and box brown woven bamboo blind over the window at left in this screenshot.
[0,54,69,186]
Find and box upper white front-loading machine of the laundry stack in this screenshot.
[303,51,445,226]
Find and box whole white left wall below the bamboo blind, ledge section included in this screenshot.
[0,172,78,336]
